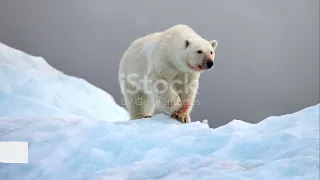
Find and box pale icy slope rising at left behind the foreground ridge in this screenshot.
[0,43,128,121]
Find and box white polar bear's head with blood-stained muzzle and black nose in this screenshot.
[175,38,218,73]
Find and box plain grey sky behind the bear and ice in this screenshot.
[0,0,319,127]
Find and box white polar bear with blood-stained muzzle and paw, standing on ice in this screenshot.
[118,24,218,123]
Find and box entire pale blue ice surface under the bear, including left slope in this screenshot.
[0,43,320,180]
